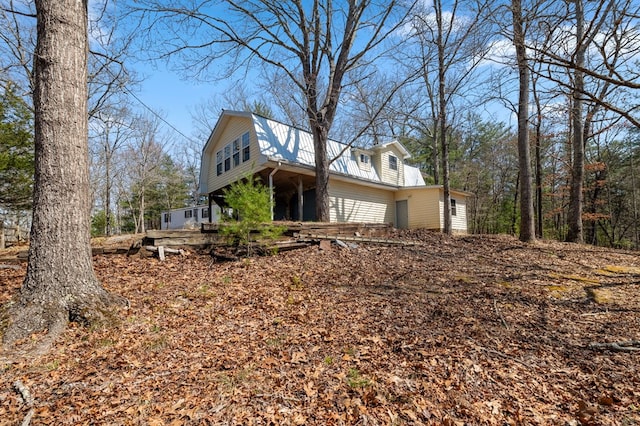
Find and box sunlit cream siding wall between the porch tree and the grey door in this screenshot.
[329,180,395,223]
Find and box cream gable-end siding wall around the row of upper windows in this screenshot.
[207,117,260,192]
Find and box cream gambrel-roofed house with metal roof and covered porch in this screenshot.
[200,111,471,233]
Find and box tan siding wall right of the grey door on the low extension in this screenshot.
[396,188,443,230]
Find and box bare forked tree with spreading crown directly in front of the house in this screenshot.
[132,0,418,221]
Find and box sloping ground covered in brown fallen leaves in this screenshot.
[0,232,640,425]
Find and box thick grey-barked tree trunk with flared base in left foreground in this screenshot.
[3,0,122,345]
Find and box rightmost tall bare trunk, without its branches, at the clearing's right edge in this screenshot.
[566,0,587,243]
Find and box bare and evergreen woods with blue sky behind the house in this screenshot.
[0,0,640,248]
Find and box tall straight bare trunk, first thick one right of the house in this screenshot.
[511,0,536,241]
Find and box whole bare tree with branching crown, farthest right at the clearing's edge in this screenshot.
[529,0,640,242]
